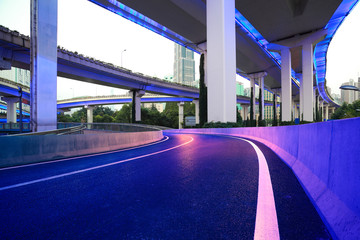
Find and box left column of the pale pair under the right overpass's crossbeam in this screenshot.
[281,48,291,121]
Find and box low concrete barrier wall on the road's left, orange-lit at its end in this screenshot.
[0,131,163,167]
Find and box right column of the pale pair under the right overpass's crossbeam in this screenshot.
[302,43,314,122]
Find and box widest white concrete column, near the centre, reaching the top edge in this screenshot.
[206,0,236,122]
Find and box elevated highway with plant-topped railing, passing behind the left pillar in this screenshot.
[0,26,199,98]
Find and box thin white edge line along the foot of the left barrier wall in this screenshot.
[0,136,169,171]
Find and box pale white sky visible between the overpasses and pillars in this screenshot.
[0,0,360,99]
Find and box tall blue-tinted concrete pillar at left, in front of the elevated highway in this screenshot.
[30,0,57,132]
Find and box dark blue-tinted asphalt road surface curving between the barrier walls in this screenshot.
[0,134,331,240]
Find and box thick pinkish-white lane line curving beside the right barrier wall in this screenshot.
[228,137,280,240]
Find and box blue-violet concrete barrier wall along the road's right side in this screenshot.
[164,118,360,239]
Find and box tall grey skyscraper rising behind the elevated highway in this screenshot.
[174,43,195,86]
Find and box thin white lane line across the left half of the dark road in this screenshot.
[0,137,194,191]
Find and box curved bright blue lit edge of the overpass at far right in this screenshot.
[314,0,358,105]
